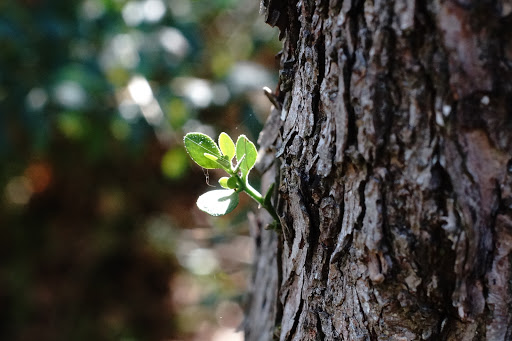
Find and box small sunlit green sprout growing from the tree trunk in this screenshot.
[183,133,279,223]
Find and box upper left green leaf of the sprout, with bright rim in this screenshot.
[183,133,222,169]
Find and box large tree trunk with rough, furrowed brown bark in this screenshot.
[246,0,512,341]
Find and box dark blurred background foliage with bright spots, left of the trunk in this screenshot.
[0,0,279,341]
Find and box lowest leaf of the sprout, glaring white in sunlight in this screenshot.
[197,189,240,216]
